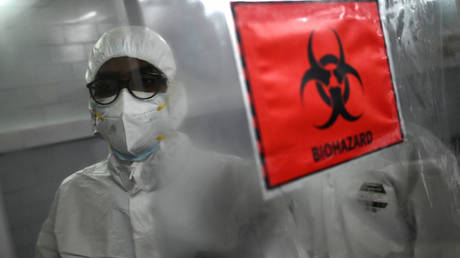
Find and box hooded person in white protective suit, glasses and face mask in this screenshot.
[36,26,257,258]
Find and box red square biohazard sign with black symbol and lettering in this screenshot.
[231,1,403,188]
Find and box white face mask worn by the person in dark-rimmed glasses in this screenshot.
[91,89,171,160]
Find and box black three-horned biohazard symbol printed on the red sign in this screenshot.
[300,29,363,129]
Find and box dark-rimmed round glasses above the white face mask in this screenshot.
[86,73,168,105]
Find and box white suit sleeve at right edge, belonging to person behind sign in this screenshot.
[407,126,460,258]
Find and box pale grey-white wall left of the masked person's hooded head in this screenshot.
[0,0,126,153]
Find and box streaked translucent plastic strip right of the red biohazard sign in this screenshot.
[381,1,449,135]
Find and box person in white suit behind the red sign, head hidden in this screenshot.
[249,124,460,258]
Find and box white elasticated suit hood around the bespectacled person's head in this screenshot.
[86,26,187,133]
